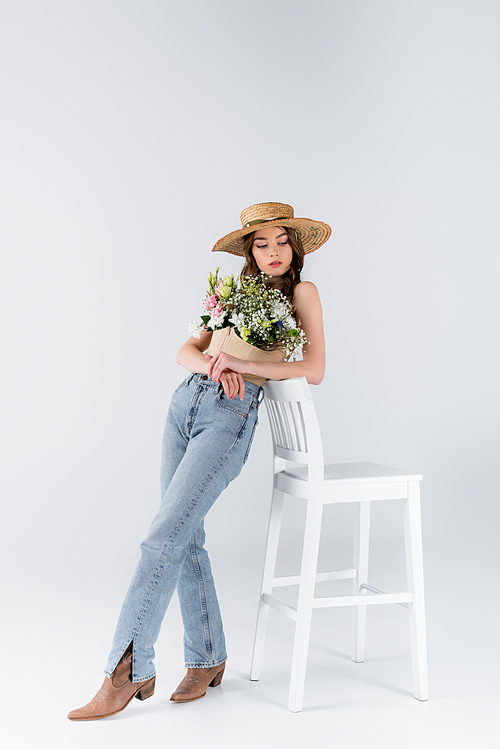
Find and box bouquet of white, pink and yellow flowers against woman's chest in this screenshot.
[189,268,307,358]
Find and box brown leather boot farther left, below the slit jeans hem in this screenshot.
[68,647,156,720]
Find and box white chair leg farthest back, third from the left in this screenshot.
[351,501,371,663]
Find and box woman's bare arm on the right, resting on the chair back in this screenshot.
[207,281,325,385]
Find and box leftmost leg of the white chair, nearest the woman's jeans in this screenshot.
[250,489,284,681]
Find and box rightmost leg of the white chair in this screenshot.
[404,481,429,701]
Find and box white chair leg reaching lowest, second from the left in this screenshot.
[288,496,323,713]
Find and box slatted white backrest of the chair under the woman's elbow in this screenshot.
[263,377,323,465]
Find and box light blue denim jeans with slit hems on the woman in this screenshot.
[105,374,261,682]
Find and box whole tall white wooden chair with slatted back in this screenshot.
[250,377,428,712]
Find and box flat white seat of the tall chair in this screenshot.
[283,461,422,486]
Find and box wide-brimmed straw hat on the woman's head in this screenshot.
[212,203,332,255]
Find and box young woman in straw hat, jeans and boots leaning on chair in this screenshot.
[68,203,331,720]
